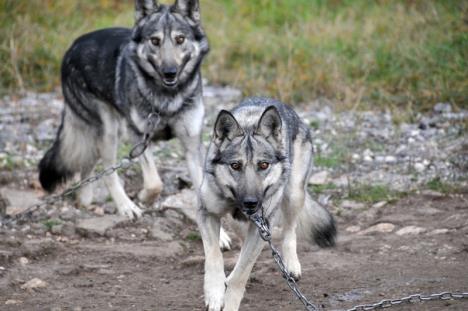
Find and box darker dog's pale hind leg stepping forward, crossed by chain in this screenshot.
[98,111,142,219]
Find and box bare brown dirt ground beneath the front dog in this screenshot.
[0,193,468,311]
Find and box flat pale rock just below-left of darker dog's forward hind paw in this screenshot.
[76,215,129,236]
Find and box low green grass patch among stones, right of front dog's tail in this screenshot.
[348,185,406,204]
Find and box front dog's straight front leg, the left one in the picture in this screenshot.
[197,207,226,311]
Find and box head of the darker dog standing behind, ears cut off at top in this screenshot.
[132,0,209,90]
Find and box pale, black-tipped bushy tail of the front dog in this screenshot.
[296,193,337,247]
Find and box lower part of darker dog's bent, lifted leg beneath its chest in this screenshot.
[138,145,163,204]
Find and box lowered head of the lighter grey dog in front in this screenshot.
[210,106,285,215]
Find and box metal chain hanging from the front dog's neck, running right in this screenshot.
[249,213,468,311]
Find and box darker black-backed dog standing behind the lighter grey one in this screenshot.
[39,0,209,218]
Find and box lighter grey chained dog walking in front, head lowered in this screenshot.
[198,98,336,311]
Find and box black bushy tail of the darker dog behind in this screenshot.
[39,118,73,192]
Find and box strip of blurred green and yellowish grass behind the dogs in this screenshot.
[0,0,468,111]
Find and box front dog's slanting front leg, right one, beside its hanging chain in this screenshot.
[224,223,265,311]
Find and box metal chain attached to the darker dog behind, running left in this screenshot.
[3,111,160,225]
